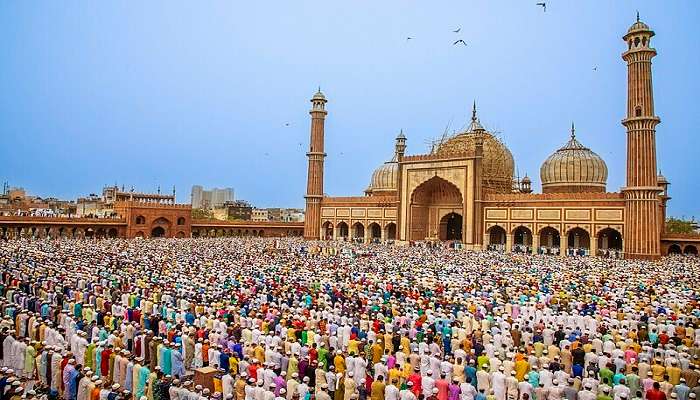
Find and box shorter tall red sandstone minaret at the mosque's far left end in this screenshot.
[304,88,328,240]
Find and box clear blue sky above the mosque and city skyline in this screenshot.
[0,0,700,217]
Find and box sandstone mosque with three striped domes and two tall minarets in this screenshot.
[304,19,698,260]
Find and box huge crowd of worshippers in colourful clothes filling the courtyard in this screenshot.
[0,238,700,400]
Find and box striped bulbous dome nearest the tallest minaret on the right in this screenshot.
[540,125,608,193]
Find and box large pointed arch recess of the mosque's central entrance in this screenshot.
[408,176,464,240]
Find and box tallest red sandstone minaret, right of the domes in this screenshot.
[622,13,664,259]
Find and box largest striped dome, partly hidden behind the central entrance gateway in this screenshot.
[433,108,515,193]
